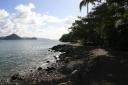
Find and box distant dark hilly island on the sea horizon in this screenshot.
[0,34,37,40]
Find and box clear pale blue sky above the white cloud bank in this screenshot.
[0,0,86,17]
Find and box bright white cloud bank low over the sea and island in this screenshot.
[0,3,77,39]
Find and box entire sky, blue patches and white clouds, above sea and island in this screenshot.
[0,0,86,39]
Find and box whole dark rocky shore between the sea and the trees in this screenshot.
[0,44,128,85]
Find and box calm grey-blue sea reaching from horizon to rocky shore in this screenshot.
[0,39,60,78]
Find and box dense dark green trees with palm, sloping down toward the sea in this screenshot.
[60,0,128,50]
